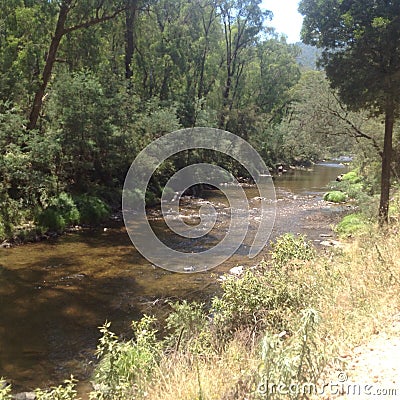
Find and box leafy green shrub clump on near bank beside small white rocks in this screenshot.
[212,234,315,336]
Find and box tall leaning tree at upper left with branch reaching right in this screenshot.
[28,0,125,130]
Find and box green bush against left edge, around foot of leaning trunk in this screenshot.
[0,102,58,238]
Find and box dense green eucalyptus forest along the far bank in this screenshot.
[0,0,360,240]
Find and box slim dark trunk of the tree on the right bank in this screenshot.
[379,97,394,226]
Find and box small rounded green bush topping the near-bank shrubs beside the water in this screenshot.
[271,233,315,268]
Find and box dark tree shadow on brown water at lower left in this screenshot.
[0,250,142,388]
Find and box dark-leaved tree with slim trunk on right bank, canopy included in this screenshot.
[299,0,400,225]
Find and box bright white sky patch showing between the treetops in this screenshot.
[261,0,303,43]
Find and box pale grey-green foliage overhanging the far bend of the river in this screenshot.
[273,71,354,164]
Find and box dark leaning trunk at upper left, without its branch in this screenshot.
[28,1,70,130]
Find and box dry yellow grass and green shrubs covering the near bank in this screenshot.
[0,226,400,400]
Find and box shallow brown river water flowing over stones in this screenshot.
[0,162,346,390]
